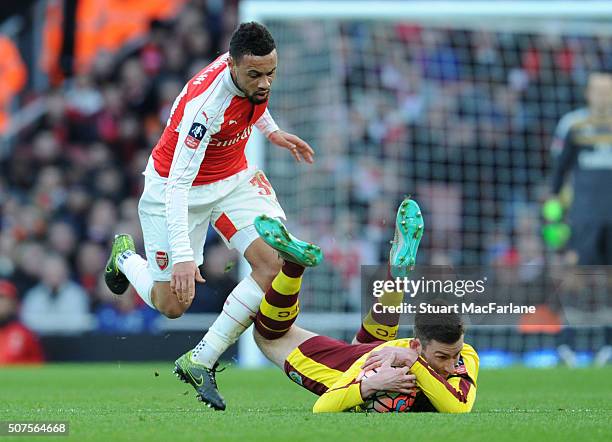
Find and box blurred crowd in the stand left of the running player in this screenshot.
[0,1,236,334]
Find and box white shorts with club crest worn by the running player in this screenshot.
[138,159,285,281]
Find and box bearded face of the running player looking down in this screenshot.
[229,49,277,104]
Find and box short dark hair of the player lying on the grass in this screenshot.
[414,301,465,347]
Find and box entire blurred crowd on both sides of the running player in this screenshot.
[0,0,612,333]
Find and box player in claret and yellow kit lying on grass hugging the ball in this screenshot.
[249,199,478,413]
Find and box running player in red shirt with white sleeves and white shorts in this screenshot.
[105,22,314,410]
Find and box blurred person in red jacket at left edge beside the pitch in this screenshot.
[0,279,43,365]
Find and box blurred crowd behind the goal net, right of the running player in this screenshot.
[267,21,612,308]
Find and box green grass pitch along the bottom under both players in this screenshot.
[0,363,612,442]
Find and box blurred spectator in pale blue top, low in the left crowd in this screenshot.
[21,255,90,333]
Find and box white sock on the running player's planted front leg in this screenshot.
[191,276,264,368]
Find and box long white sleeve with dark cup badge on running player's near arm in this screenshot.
[166,99,221,264]
